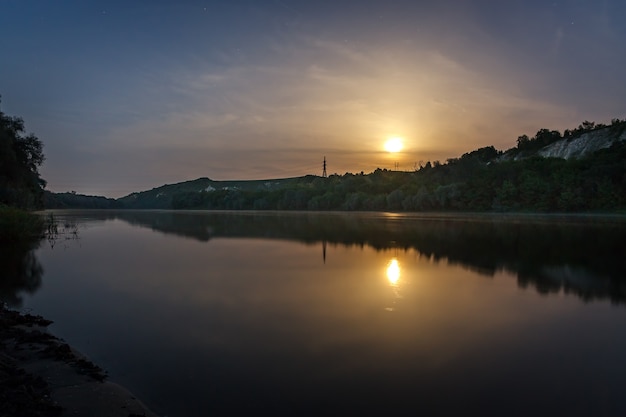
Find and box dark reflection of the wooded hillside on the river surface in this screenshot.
[106,211,626,303]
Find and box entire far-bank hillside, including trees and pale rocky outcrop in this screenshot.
[46,119,626,212]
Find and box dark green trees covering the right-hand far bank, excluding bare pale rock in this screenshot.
[171,119,626,212]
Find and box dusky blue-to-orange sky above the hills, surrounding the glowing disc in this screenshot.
[0,0,626,197]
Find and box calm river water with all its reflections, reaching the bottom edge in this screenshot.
[3,212,626,416]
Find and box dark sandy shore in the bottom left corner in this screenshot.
[0,305,156,417]
